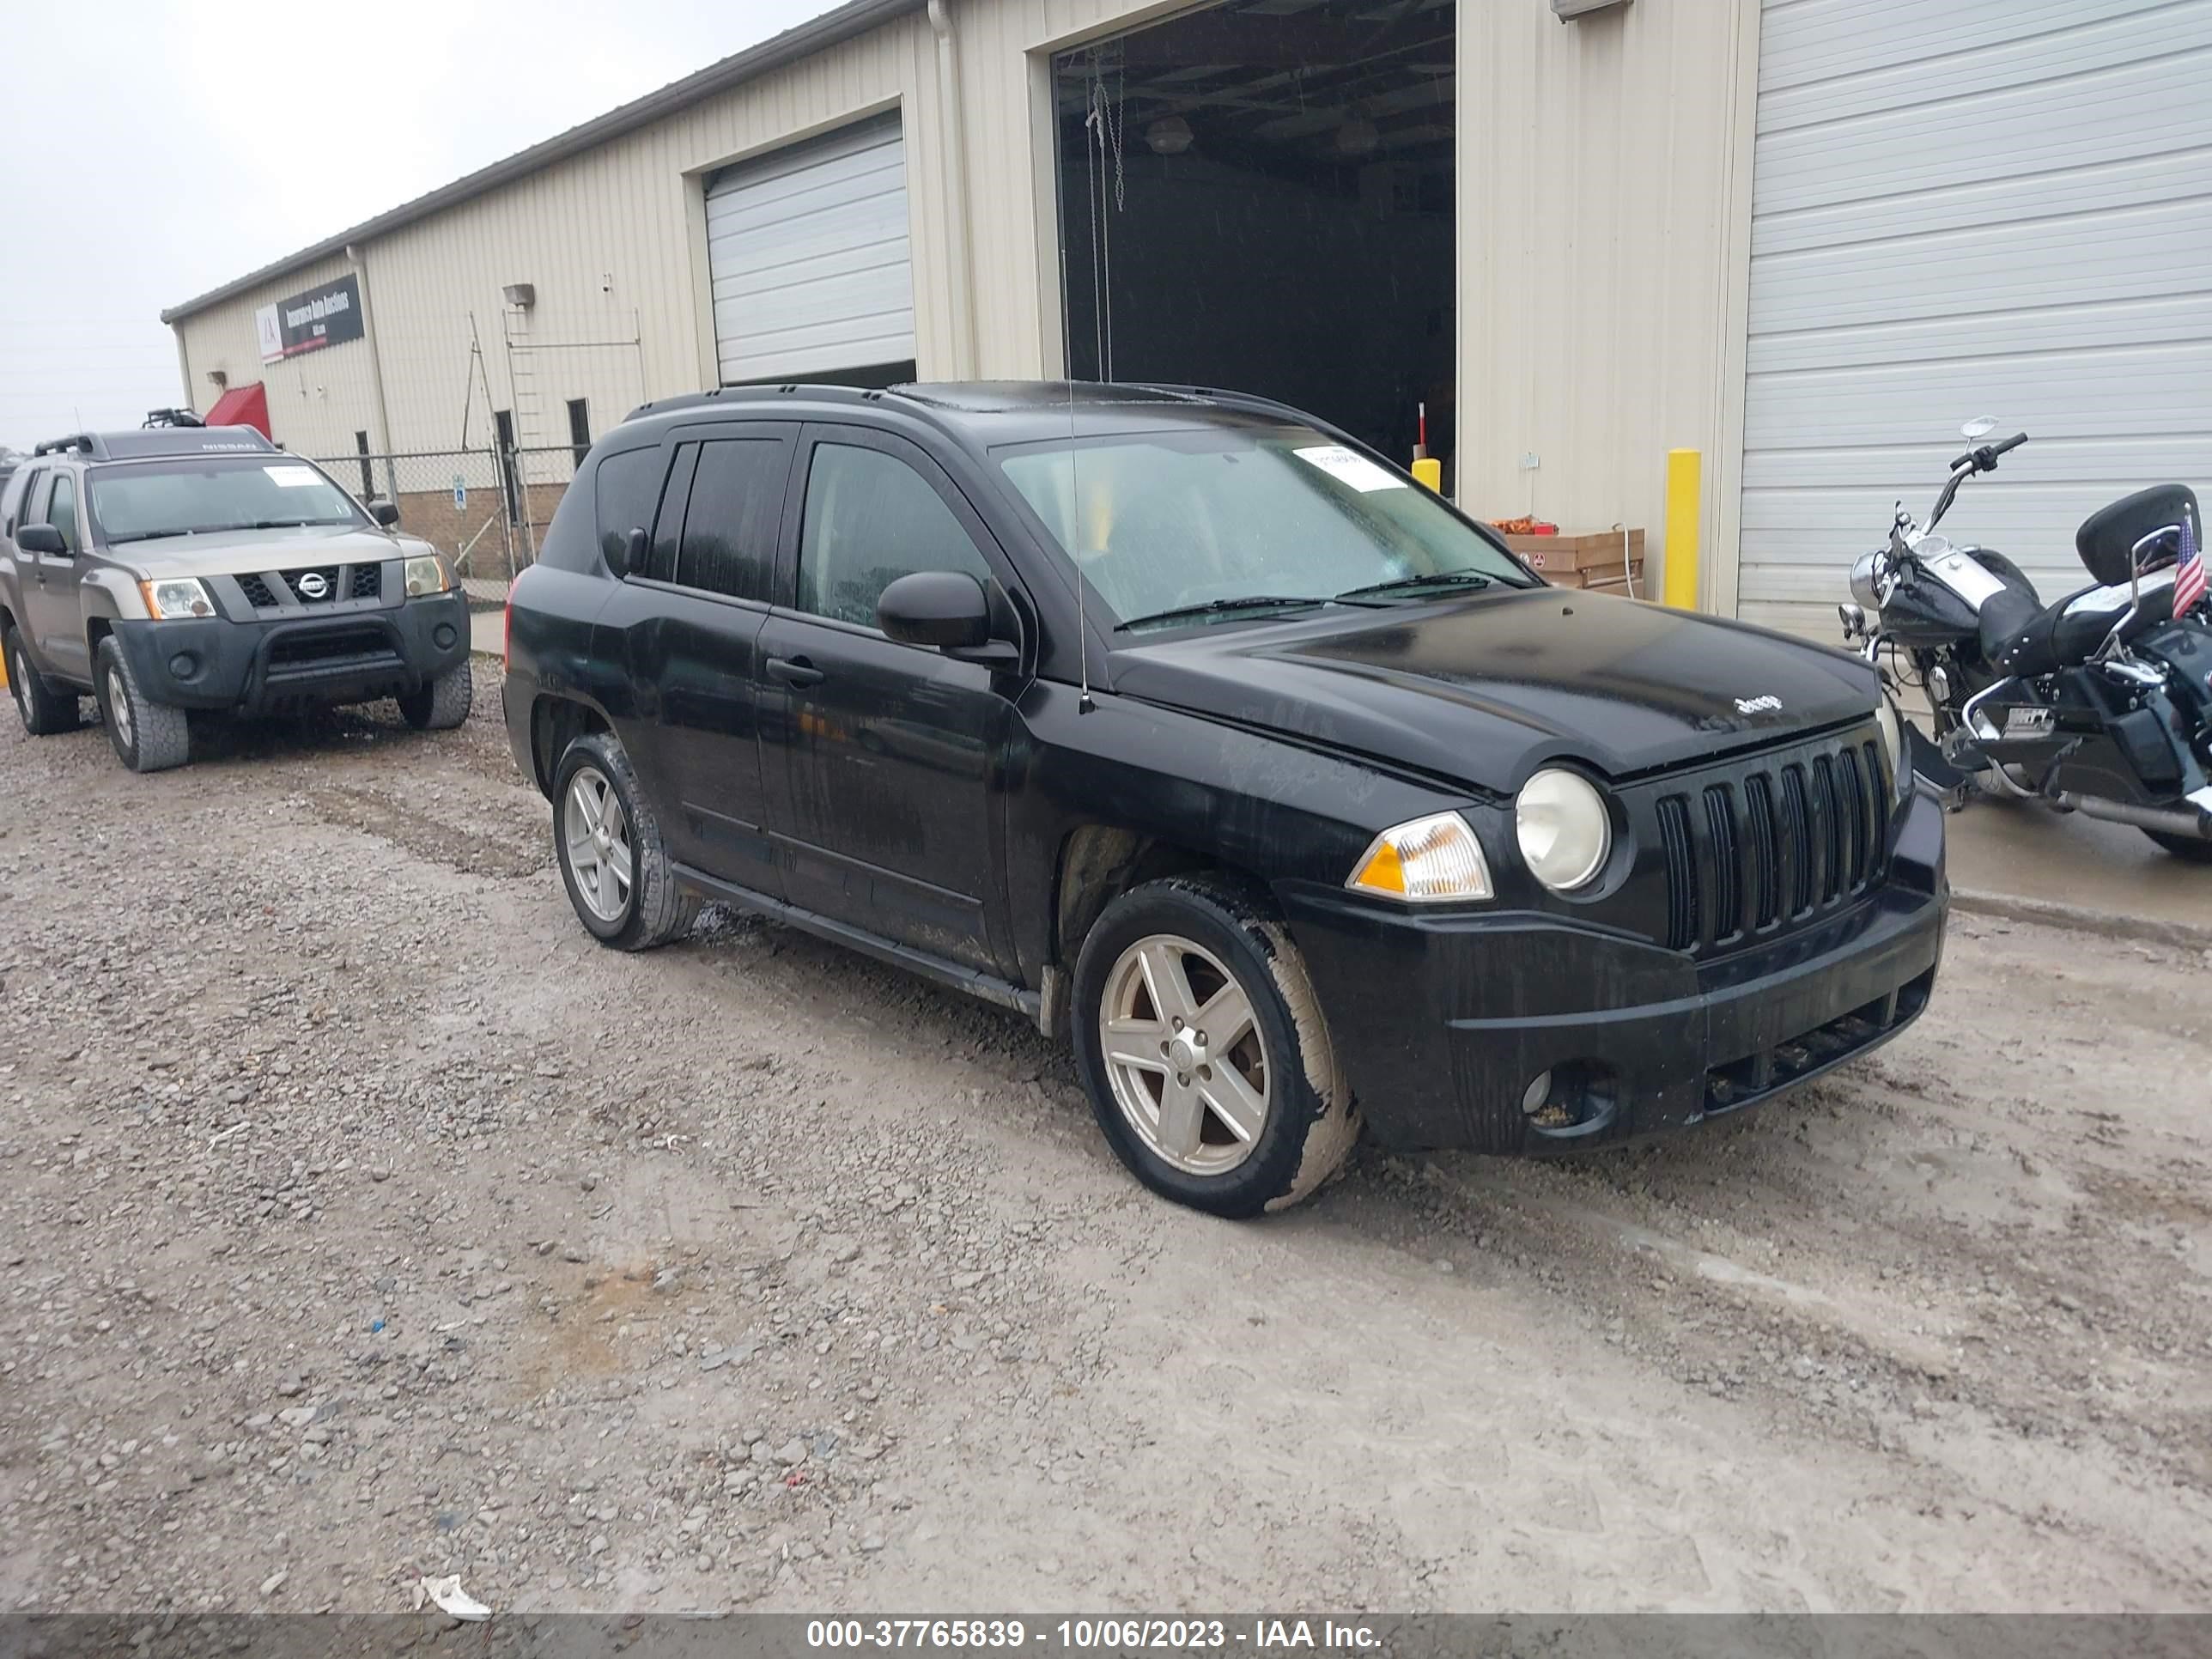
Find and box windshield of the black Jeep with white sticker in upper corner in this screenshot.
[994,427,1537,630]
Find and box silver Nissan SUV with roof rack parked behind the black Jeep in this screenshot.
[0,425,471,772]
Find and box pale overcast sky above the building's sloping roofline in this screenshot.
[0,0,836,449]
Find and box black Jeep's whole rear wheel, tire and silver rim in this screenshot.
[553,732,699,951]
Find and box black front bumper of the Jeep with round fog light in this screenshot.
[1281,794,1948,1152]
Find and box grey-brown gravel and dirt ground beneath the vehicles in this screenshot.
[0,668,2212,1613]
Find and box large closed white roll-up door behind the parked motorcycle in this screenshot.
[1741,0,2212,629]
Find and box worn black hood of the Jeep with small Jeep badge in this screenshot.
[1113,588,1878,792]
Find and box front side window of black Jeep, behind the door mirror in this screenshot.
[799,442,991,629]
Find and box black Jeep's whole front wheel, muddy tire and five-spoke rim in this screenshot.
[1073,874,1360,1221]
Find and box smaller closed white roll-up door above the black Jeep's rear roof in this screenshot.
[706,118,914,385]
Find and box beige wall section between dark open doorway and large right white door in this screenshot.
[1458,0,1759,608]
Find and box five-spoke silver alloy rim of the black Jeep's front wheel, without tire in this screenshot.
[1099,933,1272,1175]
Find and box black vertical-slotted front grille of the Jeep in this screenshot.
[1652,734,1891,953]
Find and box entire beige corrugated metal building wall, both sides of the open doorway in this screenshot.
[181,0,1756,604]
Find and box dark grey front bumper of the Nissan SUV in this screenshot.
[115,591,469,714]
